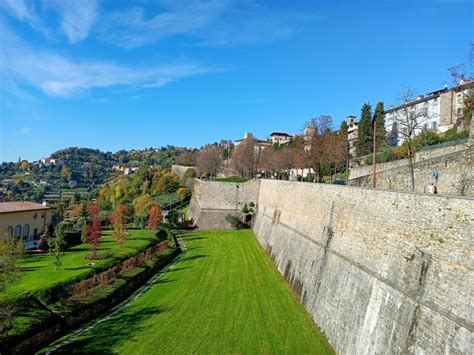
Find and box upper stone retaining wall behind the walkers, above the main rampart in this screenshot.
[349,145,474,196]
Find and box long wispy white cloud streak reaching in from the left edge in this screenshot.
[0,21,229,97]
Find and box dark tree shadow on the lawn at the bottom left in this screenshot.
[54,307,167,354]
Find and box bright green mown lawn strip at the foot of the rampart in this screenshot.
[45,230,333,354]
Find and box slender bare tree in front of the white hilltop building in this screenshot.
[394,89,428,191]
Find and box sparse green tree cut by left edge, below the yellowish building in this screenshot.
[0,232,24,292]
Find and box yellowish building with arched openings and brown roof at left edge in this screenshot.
[0,201,51,248]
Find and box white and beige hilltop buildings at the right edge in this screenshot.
[385,80,474,146]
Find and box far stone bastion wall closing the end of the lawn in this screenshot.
[188,179,260,229]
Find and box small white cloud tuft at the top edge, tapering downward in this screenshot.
[47,0,99,43]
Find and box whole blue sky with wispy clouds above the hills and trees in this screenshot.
[0,0,474,161]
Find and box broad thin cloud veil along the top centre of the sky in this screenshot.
[99,0,319,48]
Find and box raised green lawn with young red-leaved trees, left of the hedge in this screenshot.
[0,230,156,300]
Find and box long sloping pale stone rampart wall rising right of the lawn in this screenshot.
[189,180,474,354]
